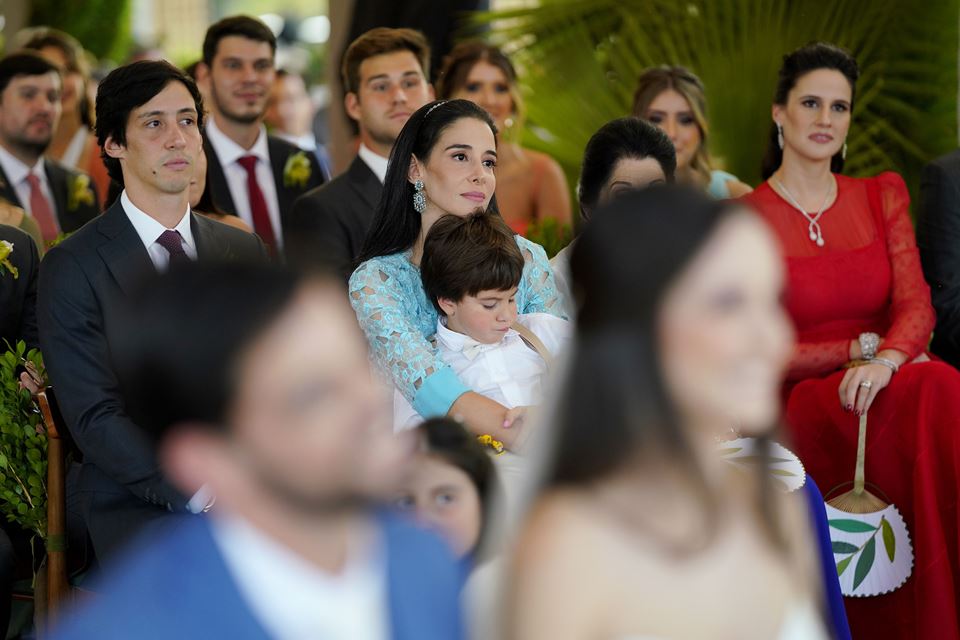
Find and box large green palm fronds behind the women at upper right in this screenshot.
[475,0,958,206]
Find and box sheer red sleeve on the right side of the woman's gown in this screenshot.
[875,173,936,361]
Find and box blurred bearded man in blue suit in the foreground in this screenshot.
[53,265,463,640]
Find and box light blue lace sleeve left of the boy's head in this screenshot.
[350,256,469,417]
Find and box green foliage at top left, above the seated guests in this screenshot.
[30,0,133,63]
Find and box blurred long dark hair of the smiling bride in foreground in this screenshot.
[547,185,782,543]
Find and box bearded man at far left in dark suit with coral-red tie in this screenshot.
[0,53,100,242]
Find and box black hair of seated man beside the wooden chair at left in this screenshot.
[96,60,203,184]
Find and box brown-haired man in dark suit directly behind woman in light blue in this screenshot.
[284,28,433,278]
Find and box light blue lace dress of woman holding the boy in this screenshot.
[349,236,566,418]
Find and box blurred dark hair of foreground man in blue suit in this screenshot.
[110,263,316,441]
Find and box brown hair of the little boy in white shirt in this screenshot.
[420,211,523,314]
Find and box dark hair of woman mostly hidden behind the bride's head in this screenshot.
[577,116,677,220]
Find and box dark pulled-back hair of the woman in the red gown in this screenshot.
[760,42,860,180]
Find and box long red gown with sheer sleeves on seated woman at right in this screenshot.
[745,173,960,640]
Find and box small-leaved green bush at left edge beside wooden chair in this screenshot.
[0,342,47,539]
